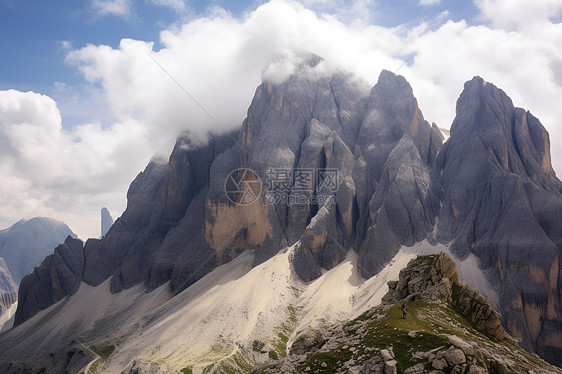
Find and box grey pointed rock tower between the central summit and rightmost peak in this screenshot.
[358,71,442,277]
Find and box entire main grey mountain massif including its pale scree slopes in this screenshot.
[4,61,562,373]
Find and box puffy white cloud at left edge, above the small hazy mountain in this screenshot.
[0,90,152,238]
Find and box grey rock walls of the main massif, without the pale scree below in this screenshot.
[12,62,562,363]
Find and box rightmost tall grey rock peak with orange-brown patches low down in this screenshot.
[436,77,562,364]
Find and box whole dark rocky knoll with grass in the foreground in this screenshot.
[254,253,562,374]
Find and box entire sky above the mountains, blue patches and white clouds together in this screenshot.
[0,0,562,238]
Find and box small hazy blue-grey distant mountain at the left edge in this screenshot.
[0,217,76,284]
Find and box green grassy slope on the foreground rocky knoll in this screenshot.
[297,301,551,373]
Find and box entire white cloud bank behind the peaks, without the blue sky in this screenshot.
[0,0,562,238]
